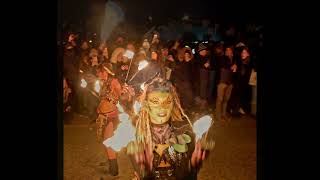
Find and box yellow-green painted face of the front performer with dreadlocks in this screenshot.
[147,91,173,124]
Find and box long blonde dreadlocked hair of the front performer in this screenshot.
[136,78,192,150]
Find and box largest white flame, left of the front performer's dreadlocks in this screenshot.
[103,113,136,151]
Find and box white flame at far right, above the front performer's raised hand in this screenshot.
[193,115,213,141]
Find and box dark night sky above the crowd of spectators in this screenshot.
[61,0,259,23]
